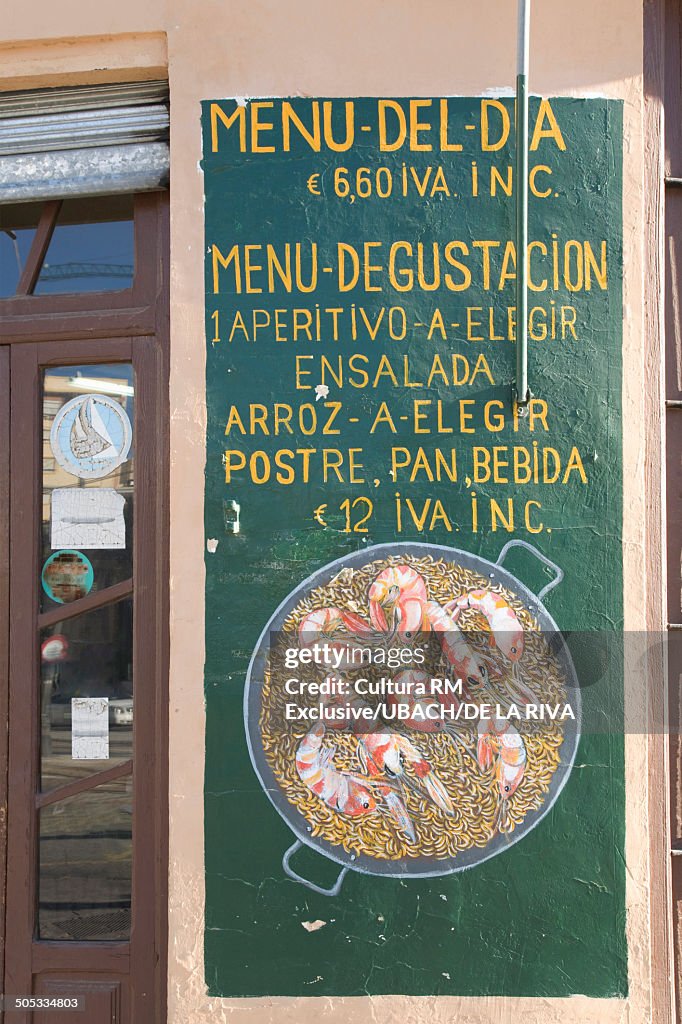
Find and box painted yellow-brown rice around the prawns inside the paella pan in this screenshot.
[259,554,567,861]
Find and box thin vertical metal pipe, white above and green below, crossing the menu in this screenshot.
[514,0,531,415]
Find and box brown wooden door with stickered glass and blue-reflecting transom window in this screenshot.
[0,195,167,1024]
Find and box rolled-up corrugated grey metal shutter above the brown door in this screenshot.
[0,82,170,203]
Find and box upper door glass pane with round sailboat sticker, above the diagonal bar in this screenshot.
[41,362,135,611]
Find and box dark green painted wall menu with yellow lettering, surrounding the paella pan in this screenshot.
[202,98,627,997]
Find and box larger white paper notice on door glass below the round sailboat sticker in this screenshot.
[50,487,126,551]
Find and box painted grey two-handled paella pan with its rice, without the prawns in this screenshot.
[244,540,581,895]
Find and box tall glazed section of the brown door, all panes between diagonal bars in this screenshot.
[39,364,135,941]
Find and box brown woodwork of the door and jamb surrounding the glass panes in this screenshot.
[0,195,169,1024]
